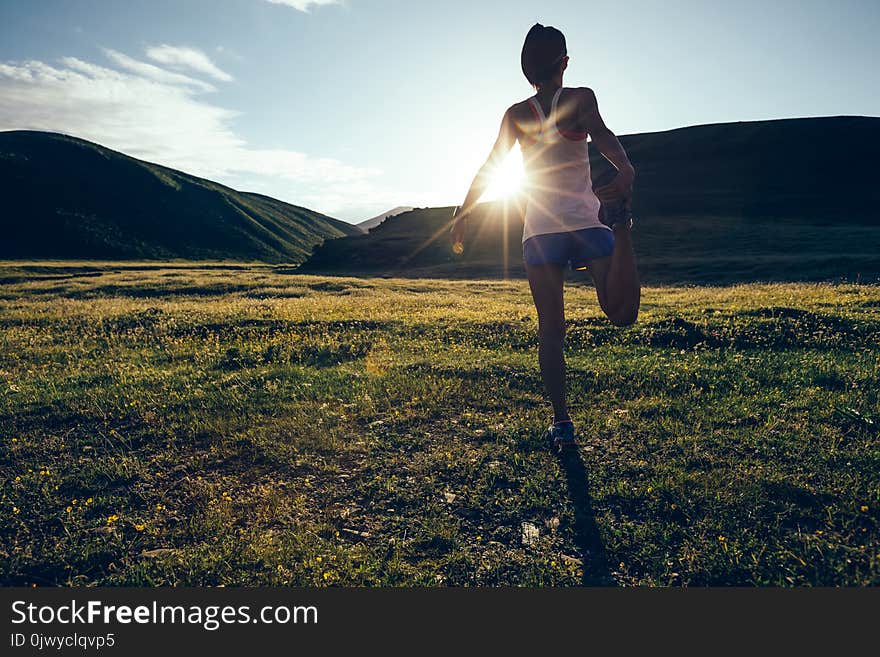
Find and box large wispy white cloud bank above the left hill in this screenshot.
[0,51,396,216]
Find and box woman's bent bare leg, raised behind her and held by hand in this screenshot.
[590,226,641,326]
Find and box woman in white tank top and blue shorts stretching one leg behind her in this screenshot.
[452,24,641,449]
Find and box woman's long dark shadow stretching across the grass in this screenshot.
[556,447,617,586]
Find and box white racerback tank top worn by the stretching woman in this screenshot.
[521,88,610,242]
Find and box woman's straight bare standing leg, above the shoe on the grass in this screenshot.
[526,265,569,422]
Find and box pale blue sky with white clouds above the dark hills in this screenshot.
[0,0,880,222]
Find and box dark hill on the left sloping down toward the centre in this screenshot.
[0,131,361,262]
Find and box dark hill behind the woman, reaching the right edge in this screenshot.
[301,117,880,283]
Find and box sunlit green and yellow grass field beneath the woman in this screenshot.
[0,263,880,586]
